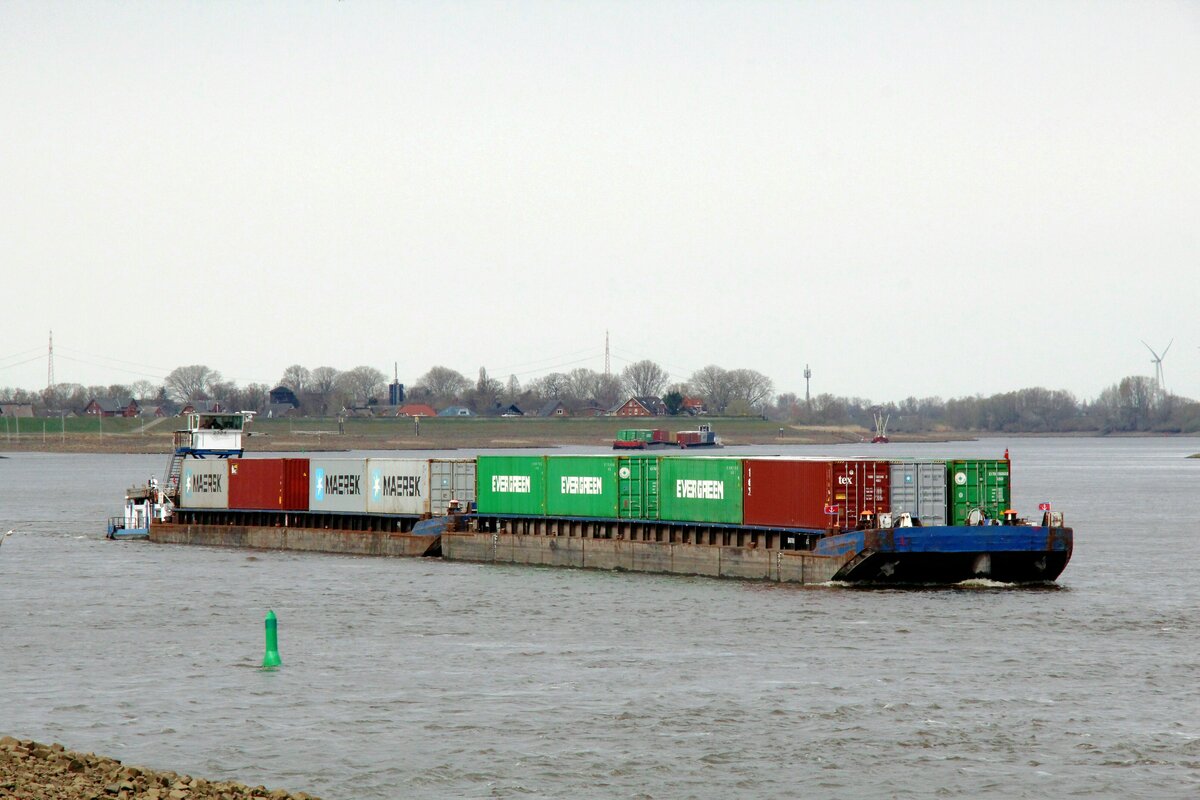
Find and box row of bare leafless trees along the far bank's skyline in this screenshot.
[0,360,1200,433]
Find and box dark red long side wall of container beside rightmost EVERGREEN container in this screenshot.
[743,458,834,530]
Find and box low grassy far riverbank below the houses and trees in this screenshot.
[0,417,955,453]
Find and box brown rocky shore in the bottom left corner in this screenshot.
[0,736,317,800]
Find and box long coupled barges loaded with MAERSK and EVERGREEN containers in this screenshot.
[133,412,1073,584]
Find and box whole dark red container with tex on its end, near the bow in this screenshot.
[742,458,890,529]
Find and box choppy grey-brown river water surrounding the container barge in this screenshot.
[0,439,1200,799]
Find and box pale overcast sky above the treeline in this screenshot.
[0,0,1200,402]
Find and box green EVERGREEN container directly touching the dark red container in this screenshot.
[659,456,742,525]
